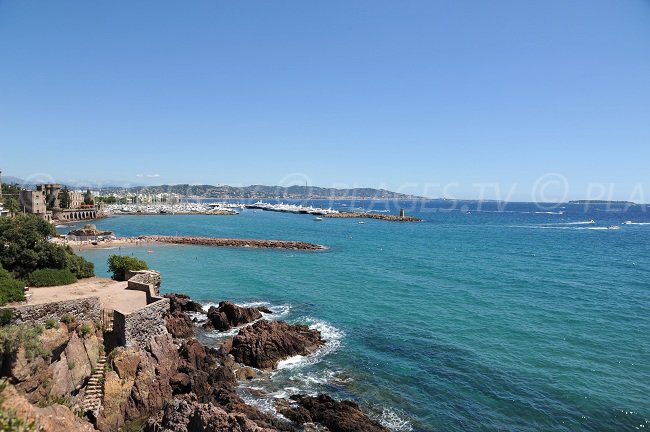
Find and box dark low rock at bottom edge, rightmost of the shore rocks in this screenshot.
[281,394,388,432]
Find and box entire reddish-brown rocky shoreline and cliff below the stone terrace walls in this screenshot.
[0,294,388,432]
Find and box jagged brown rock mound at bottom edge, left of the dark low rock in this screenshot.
[144,395,277,432]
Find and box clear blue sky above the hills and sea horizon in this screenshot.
[0,0,650,202]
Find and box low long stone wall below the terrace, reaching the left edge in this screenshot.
[0,297,100,324]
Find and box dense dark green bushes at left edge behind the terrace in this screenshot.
[0,215,94,279]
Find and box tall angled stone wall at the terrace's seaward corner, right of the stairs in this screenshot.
[113,297,169,350]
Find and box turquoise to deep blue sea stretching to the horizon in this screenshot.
[60,201,650,431]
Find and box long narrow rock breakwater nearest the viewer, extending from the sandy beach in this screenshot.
[143,235,325,250]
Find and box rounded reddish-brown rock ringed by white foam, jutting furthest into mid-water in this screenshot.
[231,321,324,370]
